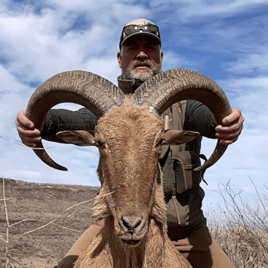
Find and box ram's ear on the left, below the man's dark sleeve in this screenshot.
[56,130,96,146]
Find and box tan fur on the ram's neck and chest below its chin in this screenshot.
[75,220,192,268]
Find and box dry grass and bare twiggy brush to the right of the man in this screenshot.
[207,178,268,268]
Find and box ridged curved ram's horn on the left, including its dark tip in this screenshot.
[26,71,125,170]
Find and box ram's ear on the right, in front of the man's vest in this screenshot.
[162,129,200,145]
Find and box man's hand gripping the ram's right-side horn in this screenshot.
[215,109,245,145]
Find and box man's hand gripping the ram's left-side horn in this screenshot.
[15,110,46,147]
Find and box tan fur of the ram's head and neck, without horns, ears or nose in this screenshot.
[72,101,191,268]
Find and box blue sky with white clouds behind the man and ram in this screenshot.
[0,0,268,214]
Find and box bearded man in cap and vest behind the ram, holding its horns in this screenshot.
[16,19,244,268]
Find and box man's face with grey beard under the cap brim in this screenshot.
[117,37,163,81]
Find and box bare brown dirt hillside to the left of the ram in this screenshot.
[0,178,99,268]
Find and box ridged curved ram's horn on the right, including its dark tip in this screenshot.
[134,69,232,171]
